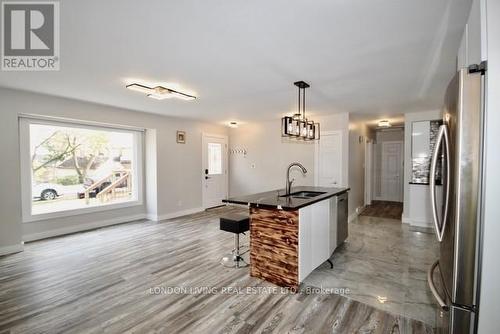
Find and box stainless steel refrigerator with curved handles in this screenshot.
[427,62,486,334]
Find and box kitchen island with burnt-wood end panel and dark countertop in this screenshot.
[224,186,349,289]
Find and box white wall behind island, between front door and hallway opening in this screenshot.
[229,113,348,196]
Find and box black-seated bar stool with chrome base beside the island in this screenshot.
[220,214,250,268]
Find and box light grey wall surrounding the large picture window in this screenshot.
[0,89,227,249]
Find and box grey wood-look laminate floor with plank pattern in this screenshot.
[0,208,432,333]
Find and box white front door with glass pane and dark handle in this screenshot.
[202,134,227,208]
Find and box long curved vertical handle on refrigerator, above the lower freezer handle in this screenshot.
[429,124,450,242]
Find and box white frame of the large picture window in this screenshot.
[19,115,145,223]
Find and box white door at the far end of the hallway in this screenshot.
[381,142,403,202]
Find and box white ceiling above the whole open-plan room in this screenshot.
[0,0,470,122]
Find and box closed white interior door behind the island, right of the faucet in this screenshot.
[315,131,343,187]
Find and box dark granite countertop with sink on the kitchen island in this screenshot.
[223,186,350,210]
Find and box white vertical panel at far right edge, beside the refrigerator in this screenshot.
[478,0,500,334]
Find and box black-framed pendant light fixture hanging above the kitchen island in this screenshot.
[281,81,319,140]
